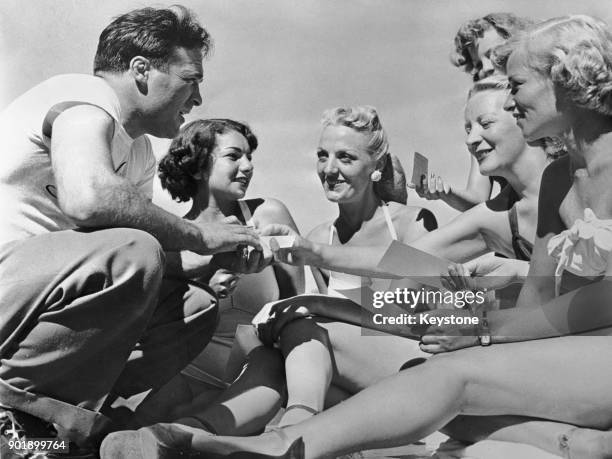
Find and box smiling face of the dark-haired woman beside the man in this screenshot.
[208,131,253,202]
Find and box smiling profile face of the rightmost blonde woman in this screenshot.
[506,49,567,142]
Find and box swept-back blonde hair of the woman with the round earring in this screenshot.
[321,105,408,204]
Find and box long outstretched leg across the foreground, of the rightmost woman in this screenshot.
[178,336,612,458]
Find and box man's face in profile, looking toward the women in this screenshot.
[141,48,202,138]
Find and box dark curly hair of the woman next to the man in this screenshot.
[158,118,257,202]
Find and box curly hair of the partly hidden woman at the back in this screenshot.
[450,13,533,79]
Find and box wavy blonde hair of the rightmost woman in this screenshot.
[493,15,612,116]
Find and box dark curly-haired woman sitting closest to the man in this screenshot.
[143,119,304,428]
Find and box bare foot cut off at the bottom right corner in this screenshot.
[559,427,612,459]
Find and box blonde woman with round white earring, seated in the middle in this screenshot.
[260,106,437,426]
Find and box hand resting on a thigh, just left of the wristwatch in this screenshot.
[419,309,480,354]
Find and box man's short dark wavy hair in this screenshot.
[94,5,212,73]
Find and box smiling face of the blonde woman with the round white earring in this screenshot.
[317,125,376,203]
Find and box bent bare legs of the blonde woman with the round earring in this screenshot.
[272,318,428,426]
